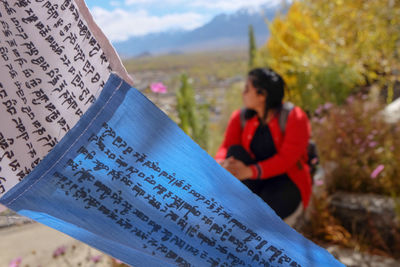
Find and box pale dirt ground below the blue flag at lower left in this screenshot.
[0,223,111,267]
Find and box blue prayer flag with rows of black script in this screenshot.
[0,74,342,266]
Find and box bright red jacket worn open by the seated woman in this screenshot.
[215,107,311,207]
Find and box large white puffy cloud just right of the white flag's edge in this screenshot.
[91,6,207,42]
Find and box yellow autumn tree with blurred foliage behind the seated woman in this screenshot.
[257,0,400,110]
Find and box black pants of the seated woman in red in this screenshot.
[226,145,301,219]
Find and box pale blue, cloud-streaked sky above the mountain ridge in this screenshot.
[85,0,281,42]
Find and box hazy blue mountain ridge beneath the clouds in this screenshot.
[113,6,282,58]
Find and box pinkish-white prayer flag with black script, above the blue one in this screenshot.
[0,0,132,196]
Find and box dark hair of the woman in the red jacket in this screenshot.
[246,68,285,120]
